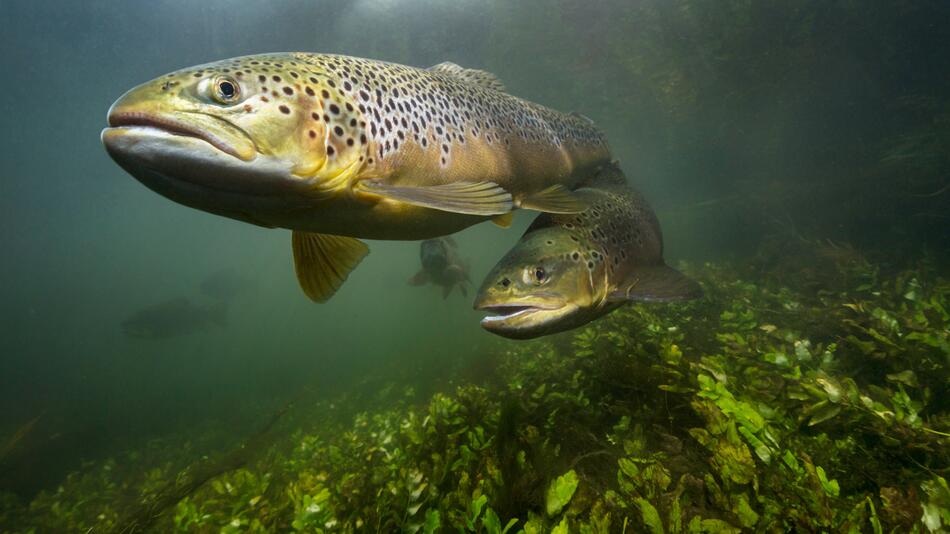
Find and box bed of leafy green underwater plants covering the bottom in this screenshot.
[0,248,950,534]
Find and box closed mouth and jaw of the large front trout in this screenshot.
[103,108,257,161]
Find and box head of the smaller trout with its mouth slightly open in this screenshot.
[475,227,598,339]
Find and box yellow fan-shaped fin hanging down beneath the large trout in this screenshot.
[293,232,369,302]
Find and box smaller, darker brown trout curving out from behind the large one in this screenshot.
[475,164,702,339]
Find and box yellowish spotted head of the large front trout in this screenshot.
[102,54,361,226]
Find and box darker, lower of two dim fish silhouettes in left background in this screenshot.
[122,298,227,339]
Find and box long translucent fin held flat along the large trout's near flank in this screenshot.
[360,180,514,217]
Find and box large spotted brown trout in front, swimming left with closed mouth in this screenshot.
[102,53,610,301]
